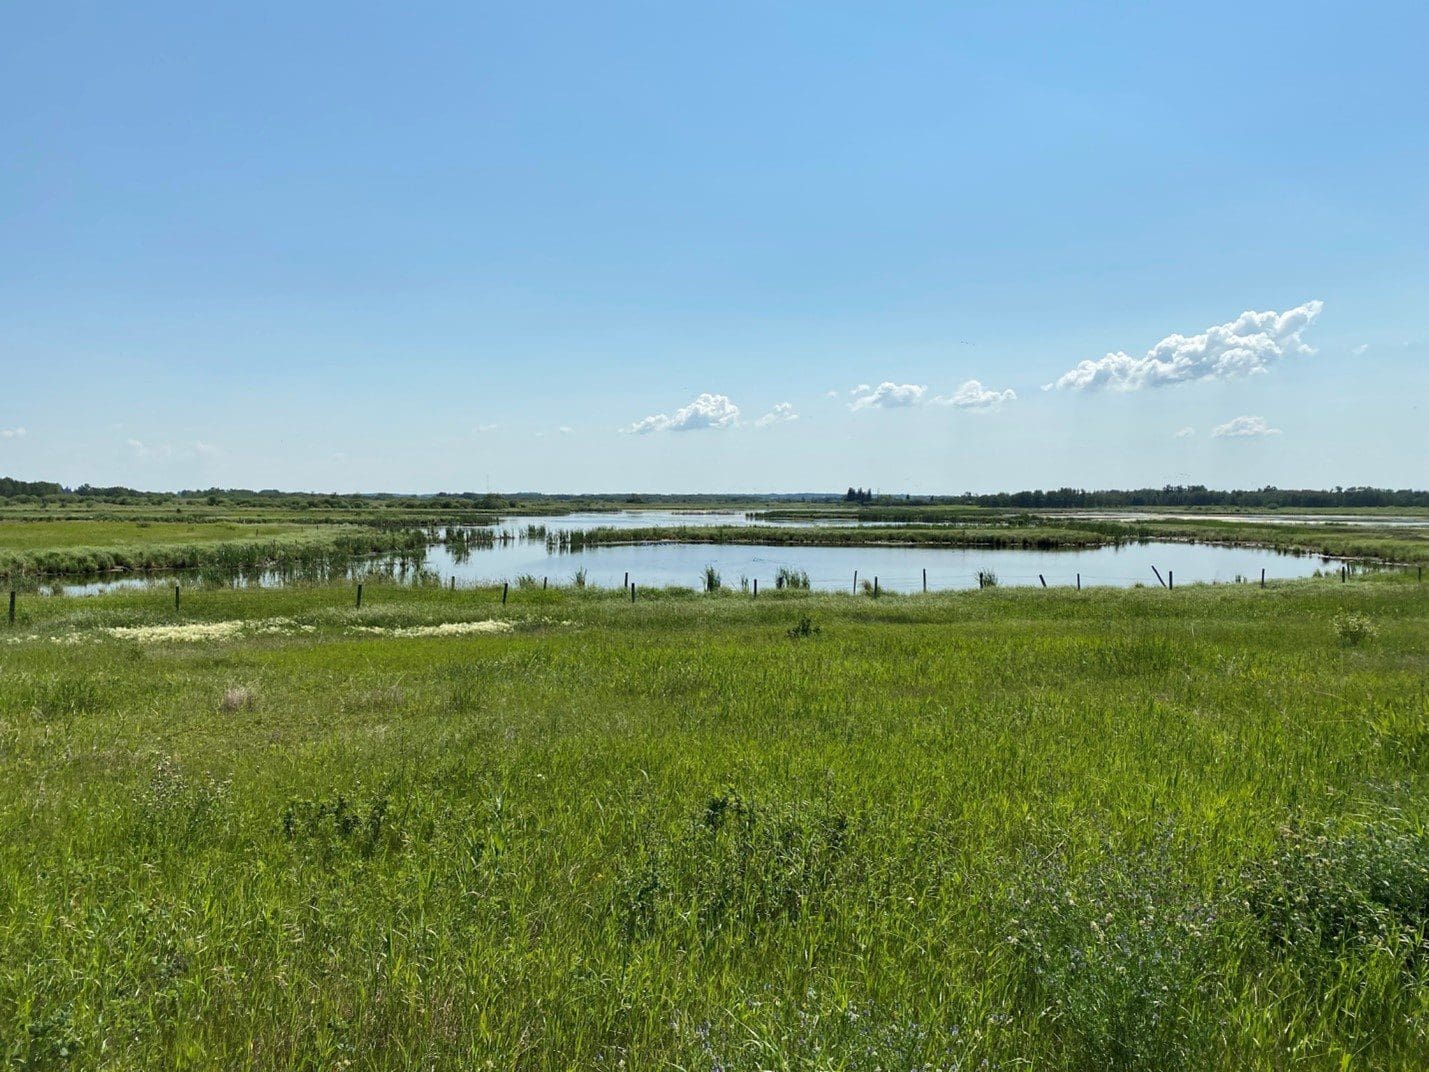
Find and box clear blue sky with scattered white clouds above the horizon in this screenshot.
[0,3,1429,493]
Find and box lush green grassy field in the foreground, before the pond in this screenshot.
[0,575,1429,1071]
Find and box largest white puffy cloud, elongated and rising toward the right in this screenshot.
[1043,300,1325,392]
